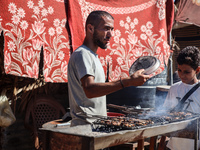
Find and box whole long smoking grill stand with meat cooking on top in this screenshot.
[41,103,199,150]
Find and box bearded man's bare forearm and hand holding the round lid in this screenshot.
[81,69,150,98]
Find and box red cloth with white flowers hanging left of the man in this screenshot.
[0,0,69,82]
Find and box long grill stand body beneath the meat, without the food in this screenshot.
[40,118,199,150]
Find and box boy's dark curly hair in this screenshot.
[177,46,200,70]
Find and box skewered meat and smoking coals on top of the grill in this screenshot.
[92,109,198,133]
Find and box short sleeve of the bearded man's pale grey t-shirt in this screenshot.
[75,52,94,79]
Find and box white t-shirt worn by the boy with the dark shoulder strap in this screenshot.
[164,81,200,150]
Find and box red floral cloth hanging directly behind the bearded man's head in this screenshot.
[65,0,173,81]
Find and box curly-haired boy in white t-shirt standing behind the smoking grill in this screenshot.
[164,46,200,150]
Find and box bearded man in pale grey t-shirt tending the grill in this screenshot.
[68,11,150,126]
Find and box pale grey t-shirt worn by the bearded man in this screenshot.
[68,45,107,126]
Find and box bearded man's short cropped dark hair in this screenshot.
[85,10,114,30]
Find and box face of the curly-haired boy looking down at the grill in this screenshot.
[178,64,199,84]
